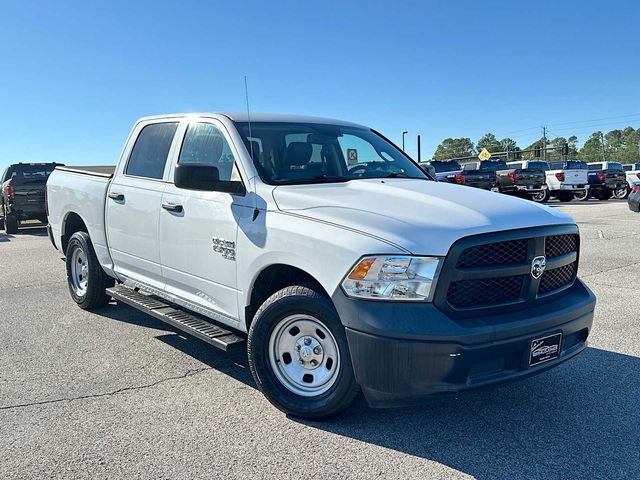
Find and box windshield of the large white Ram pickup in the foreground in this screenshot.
[236,122,429,185]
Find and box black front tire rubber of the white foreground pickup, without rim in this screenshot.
[247,285,360,420]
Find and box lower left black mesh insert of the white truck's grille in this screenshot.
[447,275,524,308]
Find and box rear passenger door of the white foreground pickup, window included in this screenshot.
[106,119,179,288]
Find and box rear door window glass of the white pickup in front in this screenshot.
[124,123,178,179]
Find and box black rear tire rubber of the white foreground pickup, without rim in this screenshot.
[66,232,114,310]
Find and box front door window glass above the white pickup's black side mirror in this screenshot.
[178,123,240,180]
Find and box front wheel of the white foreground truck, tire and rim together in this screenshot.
[248,286,359,419]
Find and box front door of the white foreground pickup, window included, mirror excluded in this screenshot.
[160,119,252,324]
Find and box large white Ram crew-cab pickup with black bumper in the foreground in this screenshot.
[47,114,595,419]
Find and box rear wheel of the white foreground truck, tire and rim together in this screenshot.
[66,232,114,310]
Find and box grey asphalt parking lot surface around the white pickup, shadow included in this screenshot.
[0,201,640,480]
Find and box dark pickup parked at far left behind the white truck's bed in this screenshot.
[0,163,61,234]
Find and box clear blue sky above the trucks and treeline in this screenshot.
[0,0,640,172]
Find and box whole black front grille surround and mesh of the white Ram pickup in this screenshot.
[434,226,580,317]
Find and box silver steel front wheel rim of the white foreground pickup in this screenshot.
[269,314,340,397]
